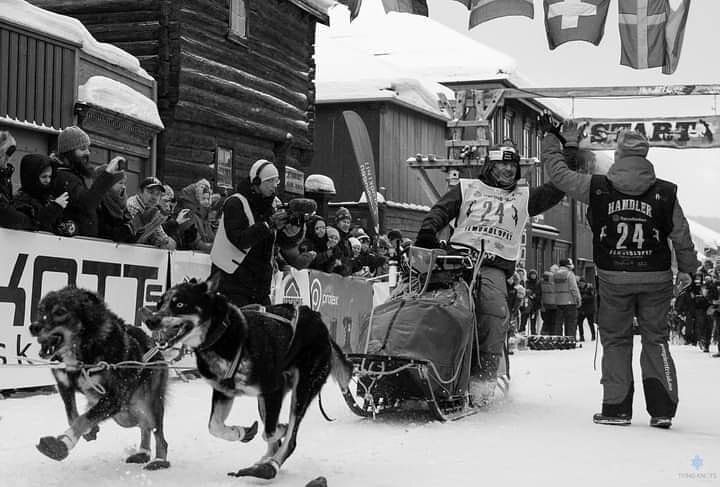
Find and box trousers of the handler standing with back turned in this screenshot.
[598,281,678,418]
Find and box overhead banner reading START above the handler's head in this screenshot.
[576,116,720,150]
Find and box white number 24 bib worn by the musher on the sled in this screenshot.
[450,179,530,261]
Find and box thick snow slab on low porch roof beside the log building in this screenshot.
[78,76,164,128]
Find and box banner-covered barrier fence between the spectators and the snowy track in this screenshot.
[0,229,389,390]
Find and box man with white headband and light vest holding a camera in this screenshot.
[210,159,289,306]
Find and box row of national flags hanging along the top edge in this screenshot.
[338,0,691,74]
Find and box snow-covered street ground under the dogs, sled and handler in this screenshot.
[0,341,720,487]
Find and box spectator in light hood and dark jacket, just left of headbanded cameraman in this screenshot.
[177,179,215,252]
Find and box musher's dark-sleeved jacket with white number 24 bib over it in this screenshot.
[418,170,565,277]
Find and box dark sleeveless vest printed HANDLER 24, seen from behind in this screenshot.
[588,175,677,272]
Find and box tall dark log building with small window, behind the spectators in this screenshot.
[33,0,334,188]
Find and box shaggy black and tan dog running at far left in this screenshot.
[30,287,170,470]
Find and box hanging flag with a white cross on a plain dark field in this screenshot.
[543,0,610,49]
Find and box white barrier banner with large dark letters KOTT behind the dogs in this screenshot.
[0,229,168,389]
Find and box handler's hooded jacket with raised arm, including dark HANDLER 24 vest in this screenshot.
[542,134,699,284]
